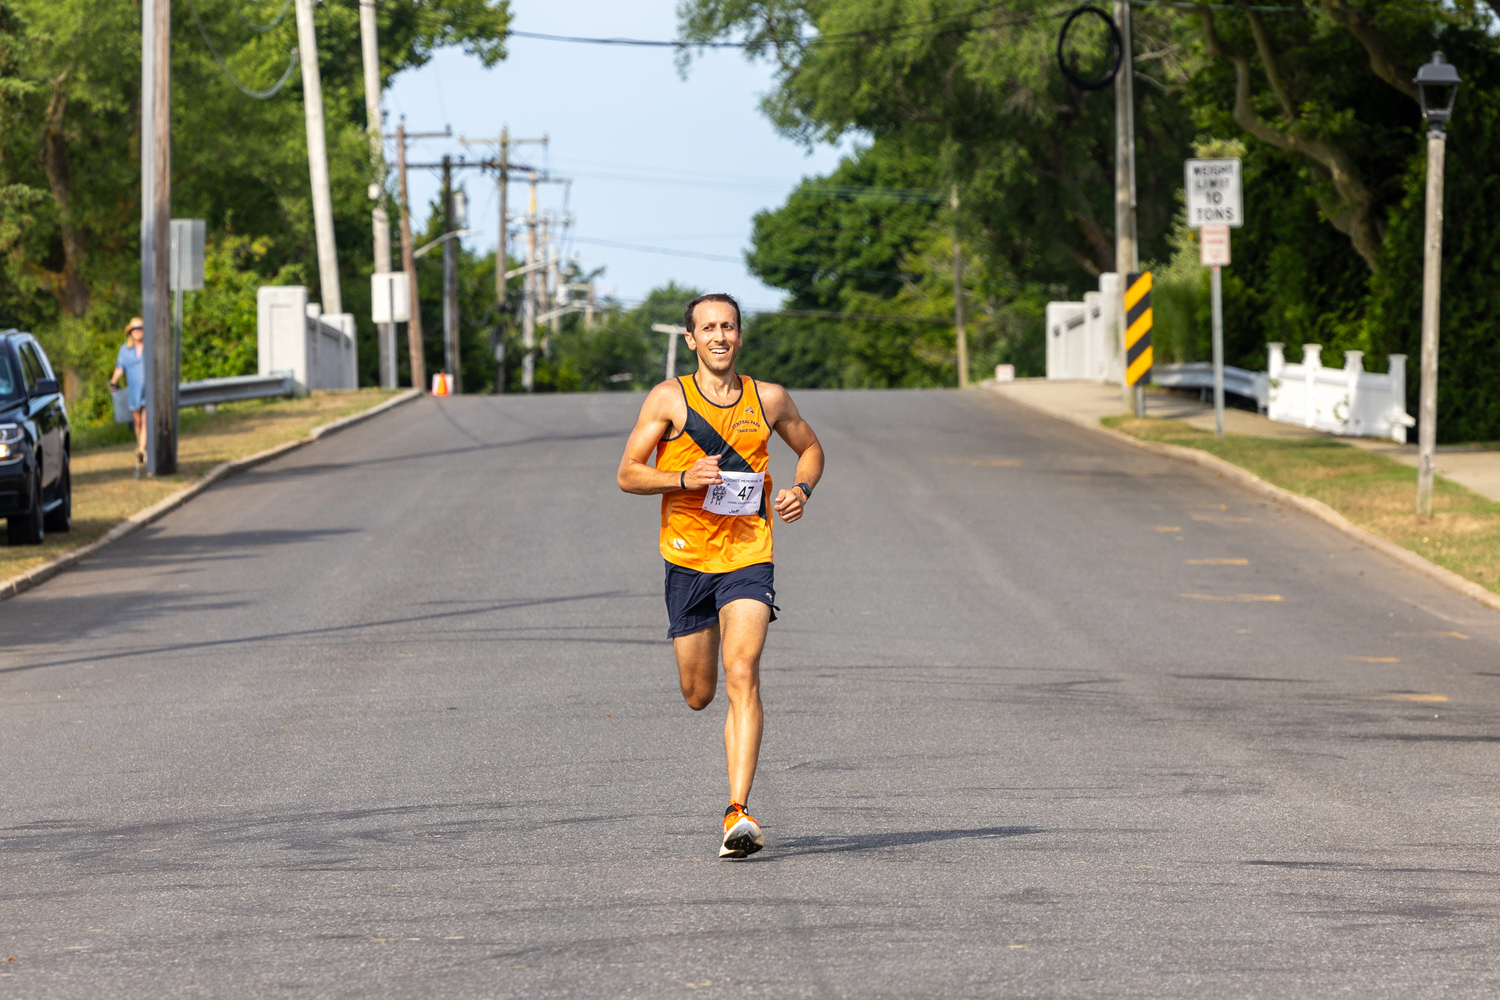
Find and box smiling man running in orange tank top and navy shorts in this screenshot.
[618,294,824,858]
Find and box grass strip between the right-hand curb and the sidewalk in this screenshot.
[1104,417,1500,594]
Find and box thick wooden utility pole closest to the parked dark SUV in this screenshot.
[141,0,177,475]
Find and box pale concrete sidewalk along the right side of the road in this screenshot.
[984,378,1500,501]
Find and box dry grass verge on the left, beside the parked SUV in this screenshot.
[0,388,395,580]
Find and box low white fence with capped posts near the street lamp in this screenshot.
[1266,343,1416,444]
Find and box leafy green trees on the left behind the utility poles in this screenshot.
[0,0,510,416]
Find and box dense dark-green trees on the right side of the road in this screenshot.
[680,0,1500,439]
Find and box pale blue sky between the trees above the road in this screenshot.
[386,0,858,307]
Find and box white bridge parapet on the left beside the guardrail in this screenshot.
[255,285,359,394]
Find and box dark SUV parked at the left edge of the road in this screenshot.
[0,330,74,546]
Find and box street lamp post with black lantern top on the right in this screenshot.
[1412,52,1458,517]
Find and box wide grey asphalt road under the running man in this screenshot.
[0,391,1500,1000]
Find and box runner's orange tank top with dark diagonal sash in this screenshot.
[657,375,773,573]
